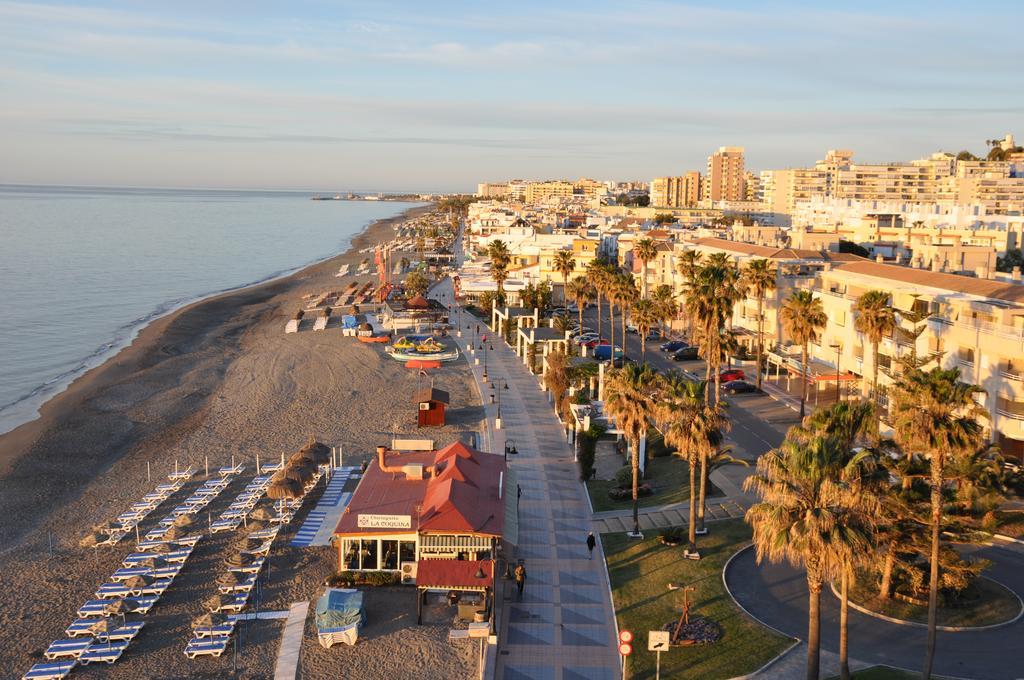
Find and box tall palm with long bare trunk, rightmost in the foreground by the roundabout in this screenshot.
[893,368,988,678]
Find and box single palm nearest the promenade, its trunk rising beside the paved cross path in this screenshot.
[604,364,657,535]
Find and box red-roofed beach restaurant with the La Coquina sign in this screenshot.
[334,441,518,622]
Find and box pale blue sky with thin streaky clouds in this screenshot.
[0,0,1024,192]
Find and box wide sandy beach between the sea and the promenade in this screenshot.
[0,208,482,678]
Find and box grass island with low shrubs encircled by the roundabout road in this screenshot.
[850,577,1021,626]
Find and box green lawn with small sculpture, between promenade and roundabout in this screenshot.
[601,519,793,680]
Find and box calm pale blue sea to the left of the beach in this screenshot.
[0,185,415,432]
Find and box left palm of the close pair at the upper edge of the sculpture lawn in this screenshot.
[657,371,711,553]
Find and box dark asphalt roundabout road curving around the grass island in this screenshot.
[726,546,1024,680]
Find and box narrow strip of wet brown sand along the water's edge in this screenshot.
[0,204,431,536]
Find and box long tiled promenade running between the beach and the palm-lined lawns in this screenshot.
[438,280,620,680]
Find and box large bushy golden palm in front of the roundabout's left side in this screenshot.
[743,433,871,680]
